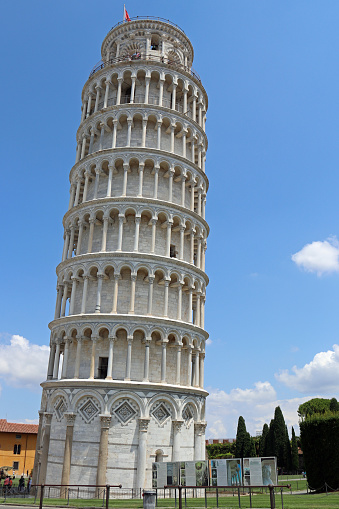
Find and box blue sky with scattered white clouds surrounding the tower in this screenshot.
[0,0,339,438]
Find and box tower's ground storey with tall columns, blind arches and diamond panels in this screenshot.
[38,380,207,488]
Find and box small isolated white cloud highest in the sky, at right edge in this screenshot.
[292,237,339,276]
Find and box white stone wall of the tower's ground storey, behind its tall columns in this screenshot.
[42,384,204,488]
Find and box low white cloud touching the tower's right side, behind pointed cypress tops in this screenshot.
[206,382,309,438]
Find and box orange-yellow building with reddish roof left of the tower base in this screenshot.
[0,419,39,475]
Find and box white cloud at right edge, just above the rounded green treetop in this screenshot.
[275,345,339,394]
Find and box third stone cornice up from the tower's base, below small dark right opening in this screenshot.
[56,251,209,286]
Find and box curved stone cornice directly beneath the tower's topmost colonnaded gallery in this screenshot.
[76,103,208,145]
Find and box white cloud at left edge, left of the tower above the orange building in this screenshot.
[0,334,49,390]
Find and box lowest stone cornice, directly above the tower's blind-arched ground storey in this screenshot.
[40,378,208,398]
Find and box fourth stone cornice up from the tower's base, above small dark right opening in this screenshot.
[62,196,210,236]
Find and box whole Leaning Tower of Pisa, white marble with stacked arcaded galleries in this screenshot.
[34,18,208,488]
